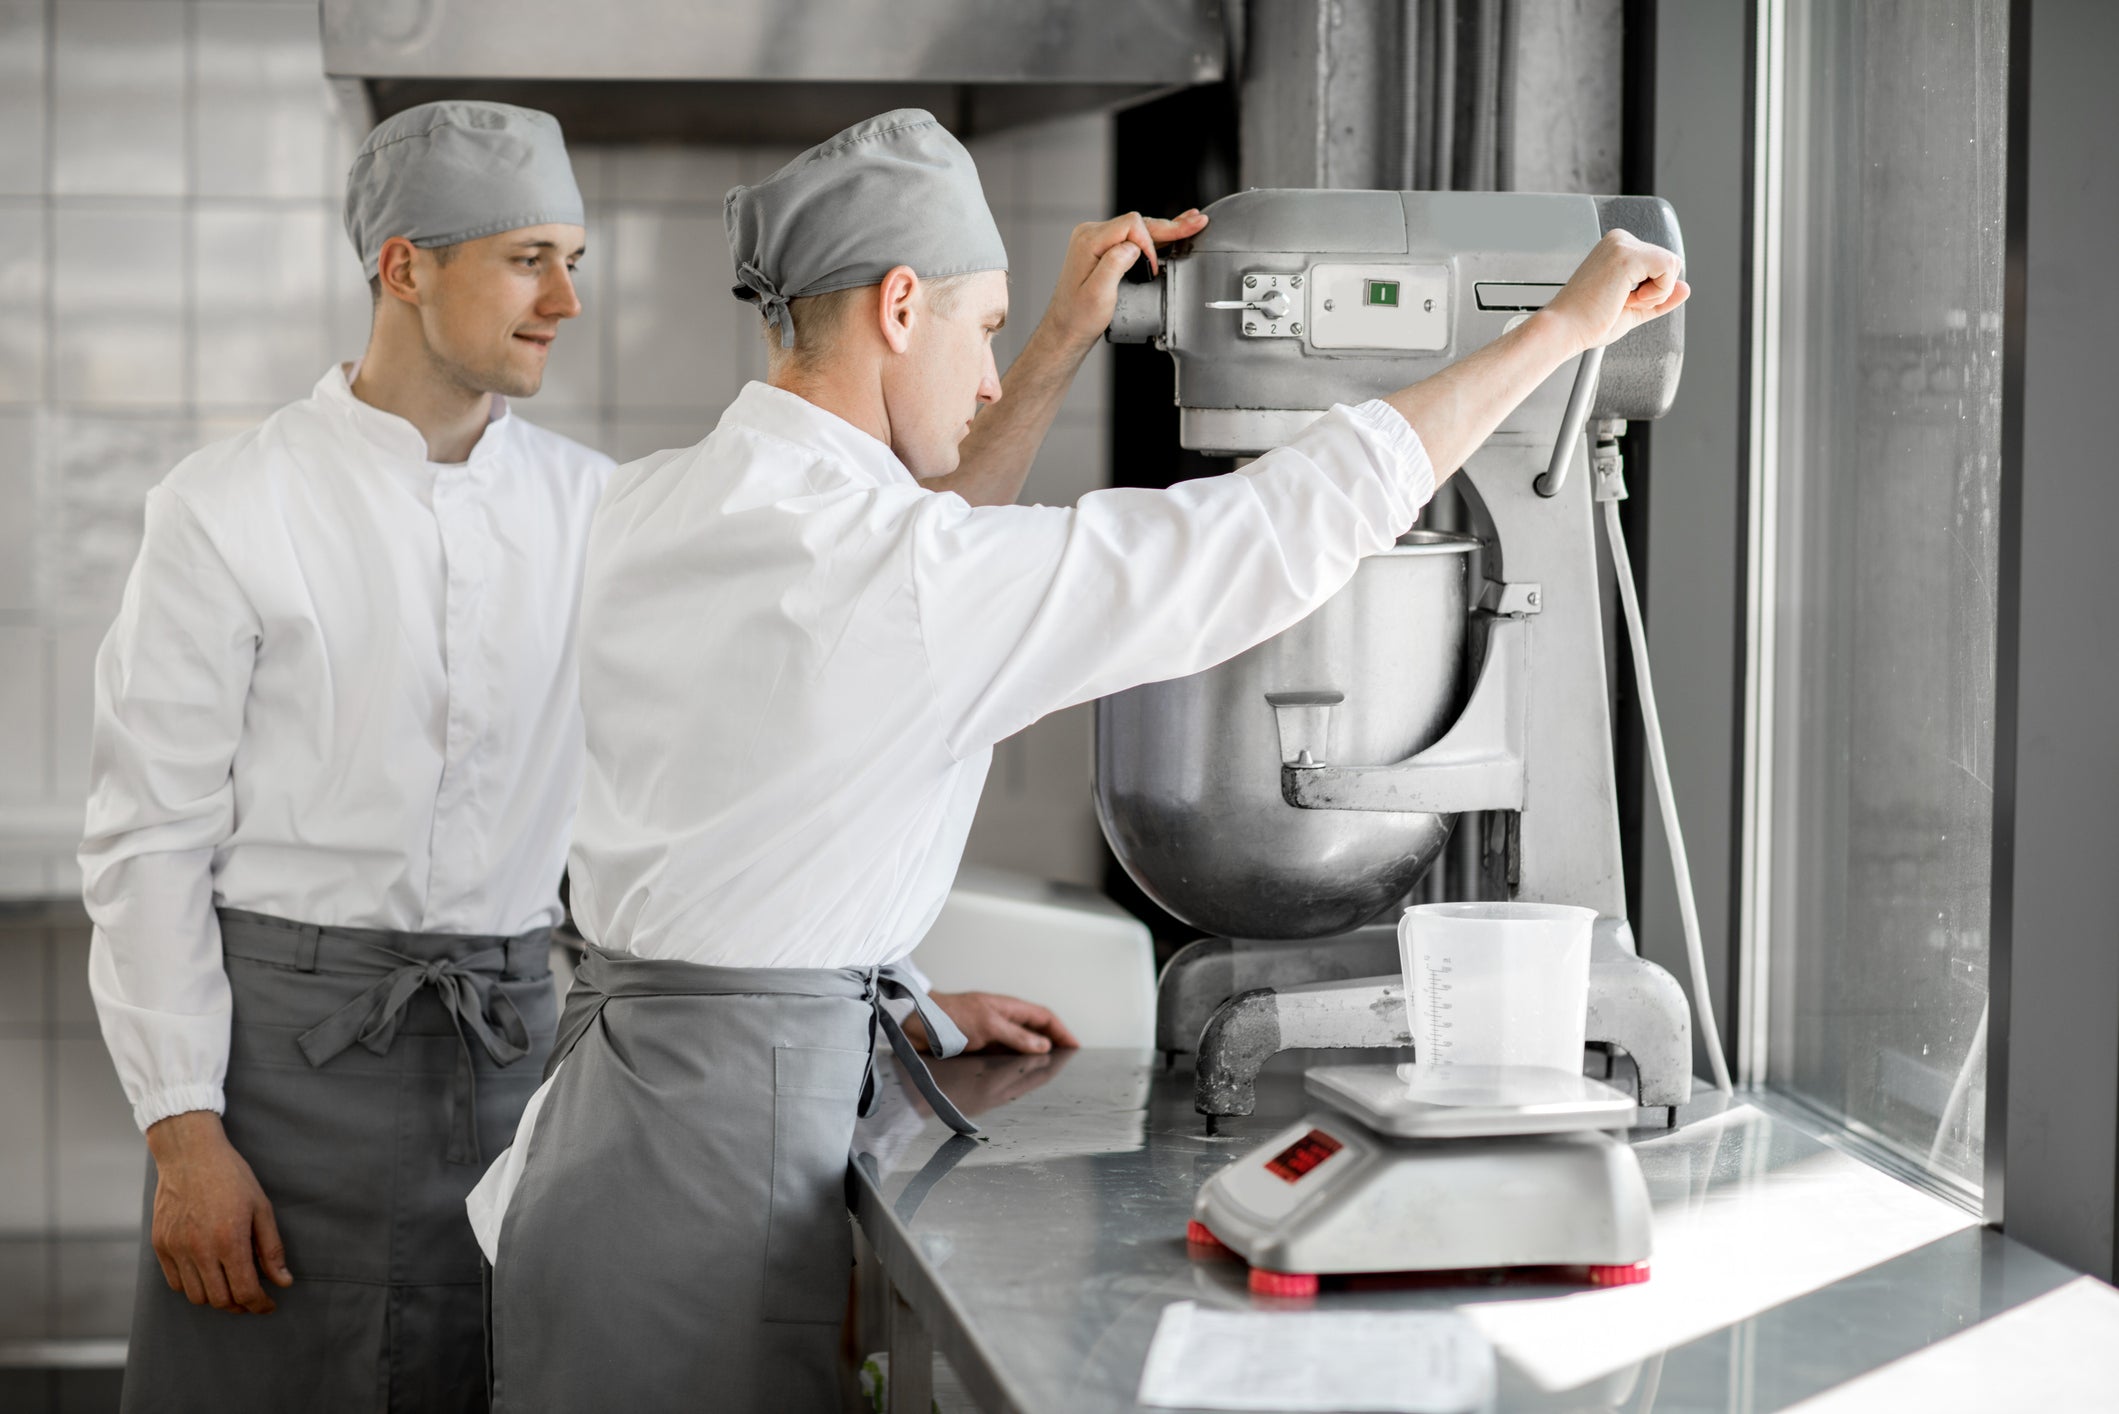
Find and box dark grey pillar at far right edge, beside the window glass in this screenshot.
[1986,0,2119,1280]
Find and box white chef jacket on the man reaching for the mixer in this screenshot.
[570,384,1435,967]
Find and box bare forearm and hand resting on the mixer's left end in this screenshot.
[928,212,1206,507]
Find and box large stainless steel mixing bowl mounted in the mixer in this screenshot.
[1096,530,1477,937]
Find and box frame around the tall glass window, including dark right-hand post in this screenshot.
[1720,0,2119,1280]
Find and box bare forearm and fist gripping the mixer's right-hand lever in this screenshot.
[1386,231,1693,481]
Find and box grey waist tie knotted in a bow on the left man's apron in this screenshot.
[222,909,545,1164]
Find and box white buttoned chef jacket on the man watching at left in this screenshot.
[81,367,610,1130]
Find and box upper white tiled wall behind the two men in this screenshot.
[0,0,1110,897]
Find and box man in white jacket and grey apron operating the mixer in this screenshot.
[470,110,1687,1414]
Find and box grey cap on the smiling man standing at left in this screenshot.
[345,100,587,280]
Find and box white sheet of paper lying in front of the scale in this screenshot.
[1140,1302,1494,1414]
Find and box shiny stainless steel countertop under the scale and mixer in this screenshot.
[854,1049,2119,1414]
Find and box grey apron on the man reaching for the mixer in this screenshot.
[487,948,975,1414]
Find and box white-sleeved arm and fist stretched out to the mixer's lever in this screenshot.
[913,233,1689,755]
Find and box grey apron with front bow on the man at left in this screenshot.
[123,909,559,1414]
